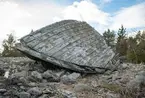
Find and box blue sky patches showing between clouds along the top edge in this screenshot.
[53,0,145,13]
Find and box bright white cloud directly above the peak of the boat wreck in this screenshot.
[55,0,110,31]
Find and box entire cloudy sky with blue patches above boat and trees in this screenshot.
[0,0,145,44]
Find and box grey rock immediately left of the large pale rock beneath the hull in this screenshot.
[42,70,59,82]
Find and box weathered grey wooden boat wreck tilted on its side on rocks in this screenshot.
[16,20,117,73]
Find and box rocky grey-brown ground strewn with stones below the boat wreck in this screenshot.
[0,57,145,98]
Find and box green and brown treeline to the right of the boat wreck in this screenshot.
[103,25,145,63]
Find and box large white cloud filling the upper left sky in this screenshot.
[0,0,63,43]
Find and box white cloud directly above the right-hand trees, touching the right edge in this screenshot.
[110,3,145,29]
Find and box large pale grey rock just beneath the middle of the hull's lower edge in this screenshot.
[61,72,81,84]
